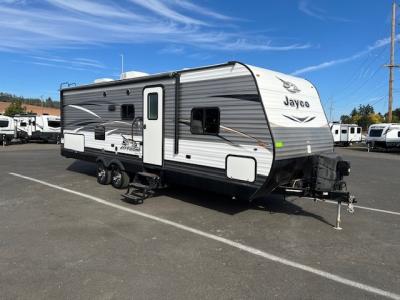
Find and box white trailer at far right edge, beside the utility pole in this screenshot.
[366,123,400,149]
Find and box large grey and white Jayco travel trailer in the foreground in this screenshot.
[60,62,353,211]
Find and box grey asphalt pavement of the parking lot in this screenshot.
[0,144,400,299]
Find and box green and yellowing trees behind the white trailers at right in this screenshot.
[340,104,400,130]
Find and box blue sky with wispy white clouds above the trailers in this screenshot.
[0,0,400,120]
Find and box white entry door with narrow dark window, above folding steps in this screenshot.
[143,87,164,166]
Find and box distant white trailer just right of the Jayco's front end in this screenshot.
[330,123,362,146]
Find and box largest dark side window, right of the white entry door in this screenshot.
[190,107,220,135]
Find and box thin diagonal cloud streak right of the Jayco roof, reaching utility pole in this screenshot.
[292,34,400,75]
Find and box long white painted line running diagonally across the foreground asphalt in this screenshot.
[9,172,400,300]
